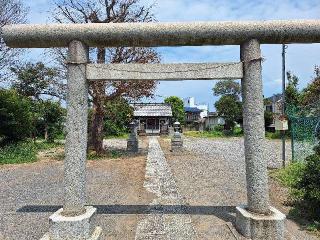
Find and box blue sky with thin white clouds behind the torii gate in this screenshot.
[24,0,320,110]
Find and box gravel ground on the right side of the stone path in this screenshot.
[161,138,316,240]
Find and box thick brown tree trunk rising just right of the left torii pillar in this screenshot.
[89,48,106,155]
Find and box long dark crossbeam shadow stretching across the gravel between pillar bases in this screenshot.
[17,205,235,222]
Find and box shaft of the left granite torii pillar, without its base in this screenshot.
[63,41,89,215]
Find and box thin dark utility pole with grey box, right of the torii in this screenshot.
[281,44,288,167]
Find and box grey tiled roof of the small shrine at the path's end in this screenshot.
[132,103,172,117]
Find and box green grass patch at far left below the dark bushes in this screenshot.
[0,141,61,165]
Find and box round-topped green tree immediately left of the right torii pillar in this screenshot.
[213,80,242,130]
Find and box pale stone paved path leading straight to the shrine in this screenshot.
[135,137,195,240]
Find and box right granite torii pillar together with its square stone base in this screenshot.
[236,39,285,240]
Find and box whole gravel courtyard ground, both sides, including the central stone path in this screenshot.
[0,138,316,240]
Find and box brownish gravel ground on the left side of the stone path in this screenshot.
[0,140,153,240]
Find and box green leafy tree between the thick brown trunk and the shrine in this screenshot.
[104,97,133,136]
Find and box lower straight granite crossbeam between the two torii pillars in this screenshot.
[87,63,243,81]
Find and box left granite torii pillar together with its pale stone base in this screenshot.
[42,41,101,240]
